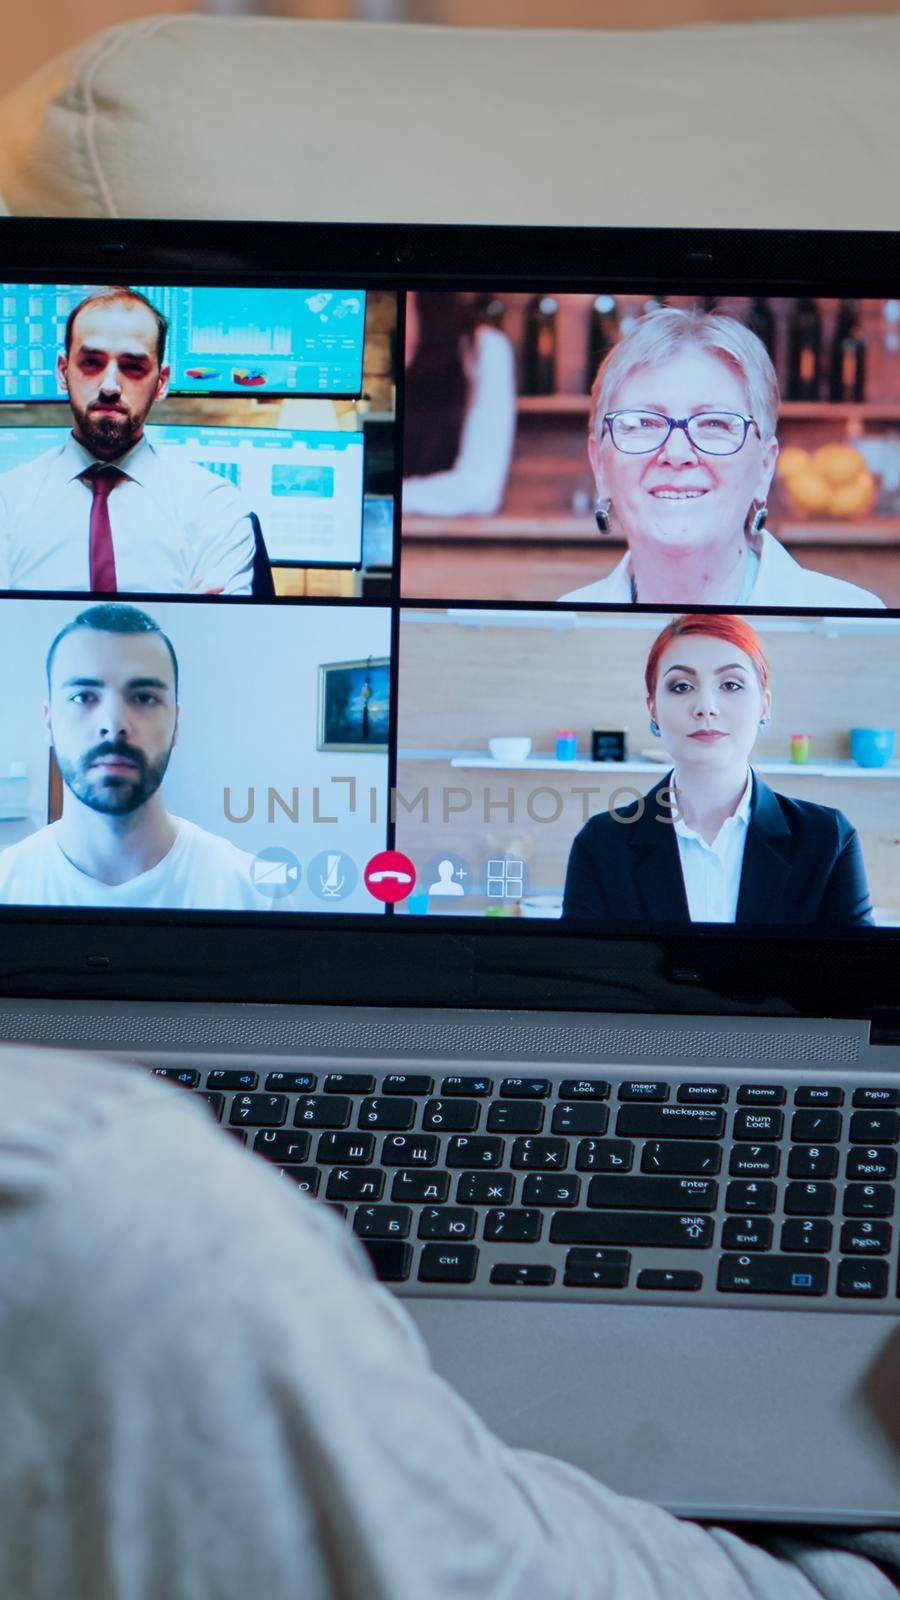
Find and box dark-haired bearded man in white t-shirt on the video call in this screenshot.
[0,602,272,910]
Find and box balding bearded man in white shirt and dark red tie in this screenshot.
[0,288,255,595]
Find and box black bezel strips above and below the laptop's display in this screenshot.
[0,218,900,1037]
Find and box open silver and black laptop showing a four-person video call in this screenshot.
[0,219,900,1526]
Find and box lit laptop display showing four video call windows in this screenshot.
[0,256,900,939]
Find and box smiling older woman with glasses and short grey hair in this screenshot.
[562,307,884,608]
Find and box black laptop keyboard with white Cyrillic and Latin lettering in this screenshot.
[143,1066,900,1310]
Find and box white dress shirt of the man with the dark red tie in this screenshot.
[0,434,253,595]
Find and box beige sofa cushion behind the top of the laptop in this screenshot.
[0,16,900,227]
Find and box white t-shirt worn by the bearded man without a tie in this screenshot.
[0,816,267,910]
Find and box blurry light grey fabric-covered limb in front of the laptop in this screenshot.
[0,1050,894,1600]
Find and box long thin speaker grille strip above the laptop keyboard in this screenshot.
[0,1006,860,1062]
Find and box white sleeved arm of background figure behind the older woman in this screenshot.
[404,328,516,517]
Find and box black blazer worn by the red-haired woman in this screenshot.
[562,773,873,928]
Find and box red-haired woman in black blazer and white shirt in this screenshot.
[562,614,873,926]
